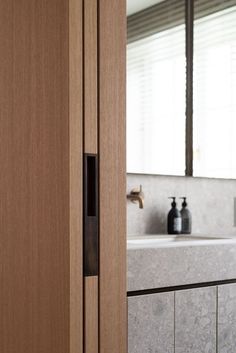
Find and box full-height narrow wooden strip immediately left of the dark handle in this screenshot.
[69,0,83,353]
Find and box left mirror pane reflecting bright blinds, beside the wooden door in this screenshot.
[127,0,186,175]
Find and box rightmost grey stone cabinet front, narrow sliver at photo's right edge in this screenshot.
[218,284,236,353]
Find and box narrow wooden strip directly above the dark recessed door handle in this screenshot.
[84,0,97,153]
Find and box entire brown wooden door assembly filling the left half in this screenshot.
[0,0,127,353]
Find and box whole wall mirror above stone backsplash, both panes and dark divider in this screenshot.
[127,0,236,178]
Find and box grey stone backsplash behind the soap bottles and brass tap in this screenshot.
[127,174,236,236]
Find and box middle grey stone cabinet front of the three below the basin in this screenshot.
[175,287,217,353]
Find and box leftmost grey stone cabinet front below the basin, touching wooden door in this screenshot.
[128,292,174,353]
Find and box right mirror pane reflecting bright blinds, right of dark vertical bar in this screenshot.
[193,0,236,178]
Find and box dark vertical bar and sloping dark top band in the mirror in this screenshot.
[128,0,235,176]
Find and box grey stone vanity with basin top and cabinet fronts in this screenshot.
[127,236,236,353]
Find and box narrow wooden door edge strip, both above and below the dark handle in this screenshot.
[83,0,98,353]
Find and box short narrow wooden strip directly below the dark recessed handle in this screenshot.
[84,276,98,353]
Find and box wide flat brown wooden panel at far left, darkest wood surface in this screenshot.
[0,0,81,353]
